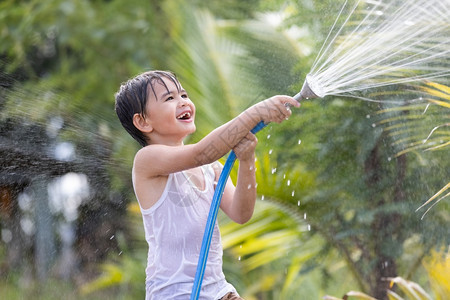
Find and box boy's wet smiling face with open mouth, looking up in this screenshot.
[145,77,196,145]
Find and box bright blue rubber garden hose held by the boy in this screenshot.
[191,121,266,300]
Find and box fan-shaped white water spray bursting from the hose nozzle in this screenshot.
[306,0,450,104]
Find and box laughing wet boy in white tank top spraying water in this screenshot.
[115,71,300,300]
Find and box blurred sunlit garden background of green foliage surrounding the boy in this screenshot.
[0,0,450,300]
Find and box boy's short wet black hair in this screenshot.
[115,71,181,147]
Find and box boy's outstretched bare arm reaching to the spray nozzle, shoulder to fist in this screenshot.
[134,96,300,178]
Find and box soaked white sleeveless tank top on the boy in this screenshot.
[137,165,236,300]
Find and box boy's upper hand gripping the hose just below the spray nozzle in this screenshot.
[249,96,300,124]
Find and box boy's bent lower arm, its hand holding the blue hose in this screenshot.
[216,133,257,224]
